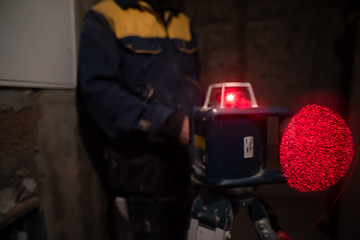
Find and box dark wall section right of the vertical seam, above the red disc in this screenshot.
[246,0,344,111]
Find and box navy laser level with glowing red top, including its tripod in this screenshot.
[187,82,291,240]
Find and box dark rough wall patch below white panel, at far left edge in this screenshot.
[0,90,41,214]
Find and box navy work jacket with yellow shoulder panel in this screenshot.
[78,0,203,141]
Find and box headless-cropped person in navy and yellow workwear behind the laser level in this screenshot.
[77,0,203,240]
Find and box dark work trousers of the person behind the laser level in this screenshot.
[107,144,192,240]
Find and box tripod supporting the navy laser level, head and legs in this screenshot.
[187,176,278,240]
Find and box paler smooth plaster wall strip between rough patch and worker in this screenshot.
[36,90,104,240]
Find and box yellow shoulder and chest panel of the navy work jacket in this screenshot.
[92,0,191,41]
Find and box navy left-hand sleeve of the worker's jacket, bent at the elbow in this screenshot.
[78,11,173,140]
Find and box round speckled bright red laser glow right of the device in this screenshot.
[280,104,354,192]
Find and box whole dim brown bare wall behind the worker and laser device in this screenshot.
[0,0,360,240]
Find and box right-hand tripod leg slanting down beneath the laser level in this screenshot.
[248,198,278,240]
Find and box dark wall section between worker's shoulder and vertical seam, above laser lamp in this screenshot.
[185,0,247,87]
